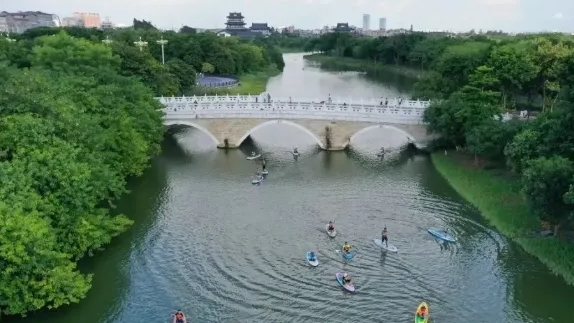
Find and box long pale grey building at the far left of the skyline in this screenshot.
[0,11,59,34]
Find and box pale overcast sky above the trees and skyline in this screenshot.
[4,0,574,32]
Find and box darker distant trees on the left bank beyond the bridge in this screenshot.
[17,25,285,96]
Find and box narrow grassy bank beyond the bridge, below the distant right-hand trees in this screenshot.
[303,54,426,79]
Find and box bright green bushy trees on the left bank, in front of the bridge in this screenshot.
[0,33,163,315]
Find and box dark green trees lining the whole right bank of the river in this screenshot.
[305,33,574,234]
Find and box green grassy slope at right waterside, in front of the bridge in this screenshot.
[432,152,574,285]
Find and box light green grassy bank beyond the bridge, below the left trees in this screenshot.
[192,65,281,95]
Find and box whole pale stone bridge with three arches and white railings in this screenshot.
[158,96,431,150]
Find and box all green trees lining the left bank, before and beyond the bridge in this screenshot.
[0,24,284,316]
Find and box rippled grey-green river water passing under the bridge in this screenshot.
[14,54,574,323]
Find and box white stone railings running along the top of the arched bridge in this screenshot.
[159,98,428,124]
